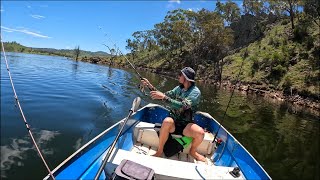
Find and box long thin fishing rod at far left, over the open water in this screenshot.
[0,34,55,179]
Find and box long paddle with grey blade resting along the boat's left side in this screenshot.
[94,97,141,180]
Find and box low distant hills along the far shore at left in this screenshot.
[1,41,111,58]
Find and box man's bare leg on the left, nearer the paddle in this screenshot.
[153,117,175,157]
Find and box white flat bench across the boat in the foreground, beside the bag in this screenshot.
[105,149,245,179]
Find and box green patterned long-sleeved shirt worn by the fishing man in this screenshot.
[165,85,201,122]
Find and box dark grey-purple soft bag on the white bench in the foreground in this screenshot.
[113,159,155,180]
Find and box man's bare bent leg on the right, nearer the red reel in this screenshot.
[183,123,206,162]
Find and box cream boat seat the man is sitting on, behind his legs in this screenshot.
[134,122,214,155]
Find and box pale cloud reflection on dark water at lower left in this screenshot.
[1,130,60,178]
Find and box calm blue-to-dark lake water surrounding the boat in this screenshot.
[1,53,320,179]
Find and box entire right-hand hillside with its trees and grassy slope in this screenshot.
[109,0,320,103]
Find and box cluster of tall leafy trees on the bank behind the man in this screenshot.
[127,8,235,79]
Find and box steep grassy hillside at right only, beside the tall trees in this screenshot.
[222,19,320,99]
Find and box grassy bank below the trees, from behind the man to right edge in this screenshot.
[115,19,320,100]
